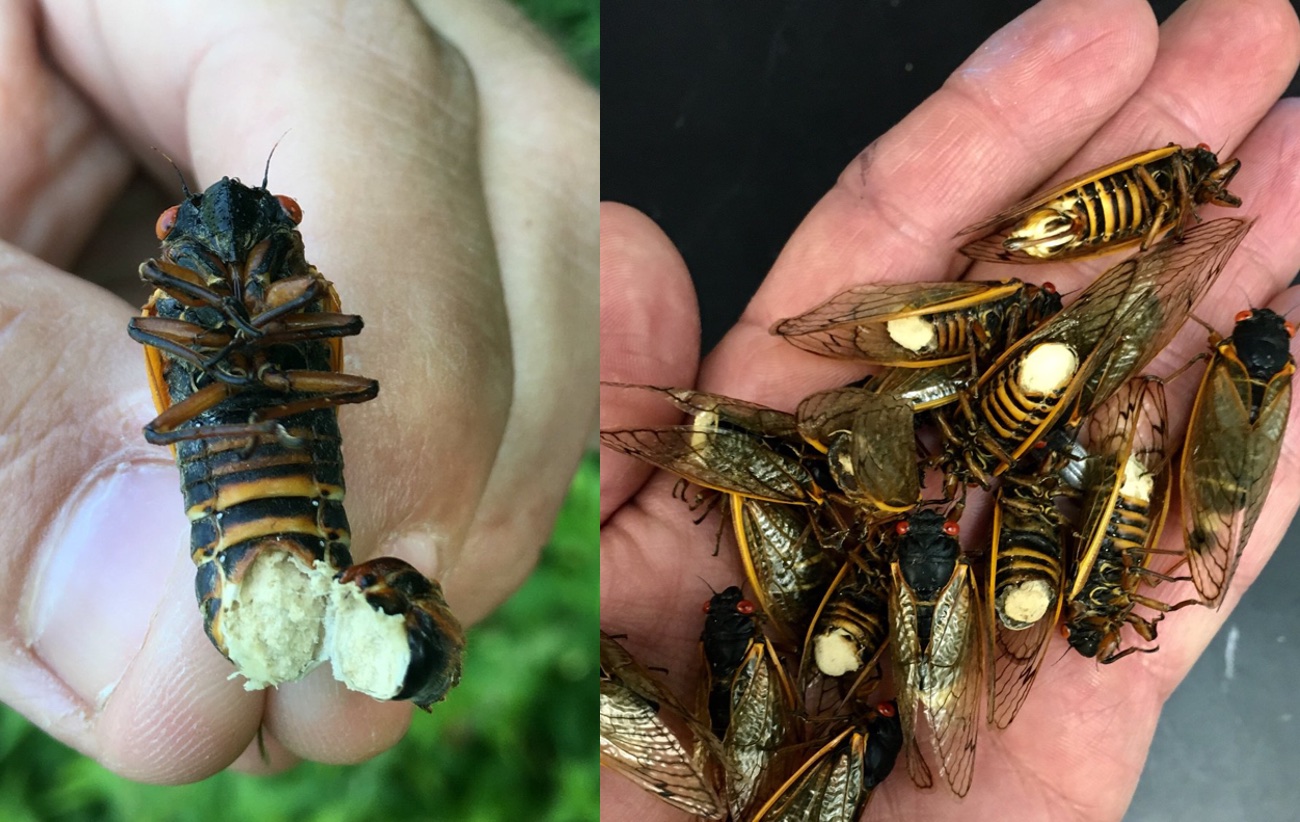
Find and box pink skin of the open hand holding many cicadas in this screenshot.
[601,0,1300,822]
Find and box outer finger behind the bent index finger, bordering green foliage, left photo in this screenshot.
[416,0,599,622]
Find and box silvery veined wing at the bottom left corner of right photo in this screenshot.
[601,680,727,819]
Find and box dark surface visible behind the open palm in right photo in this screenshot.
[601,0,1300,822]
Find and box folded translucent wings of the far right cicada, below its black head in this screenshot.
[1182,358,1294,607]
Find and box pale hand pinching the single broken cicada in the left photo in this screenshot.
[0,0,598,783]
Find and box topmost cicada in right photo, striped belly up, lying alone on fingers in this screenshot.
[958,143,1242,263]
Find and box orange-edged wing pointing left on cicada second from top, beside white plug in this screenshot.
[772,281,1023,367]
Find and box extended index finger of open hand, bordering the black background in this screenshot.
[701,0,1156,407]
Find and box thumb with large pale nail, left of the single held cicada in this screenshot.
[0,245,261,782]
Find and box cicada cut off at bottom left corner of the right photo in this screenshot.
[601,631,727,819]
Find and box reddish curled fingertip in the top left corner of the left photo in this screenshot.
[0,3,133,265]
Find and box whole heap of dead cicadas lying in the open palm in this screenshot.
[601,146,1295,822]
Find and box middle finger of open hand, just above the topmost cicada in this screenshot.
[970,0,1300,294]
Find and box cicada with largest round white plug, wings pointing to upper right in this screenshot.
[939,219,1251,486]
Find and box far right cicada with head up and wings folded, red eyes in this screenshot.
[1182,308,1296,607]
